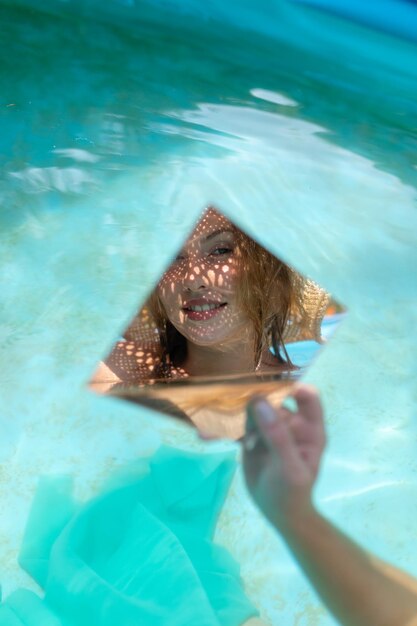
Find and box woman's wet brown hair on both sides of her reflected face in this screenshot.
[146,226,298,377]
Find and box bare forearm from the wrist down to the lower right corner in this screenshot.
[277,507,417,626]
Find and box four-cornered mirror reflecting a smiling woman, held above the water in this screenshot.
[90,207,345,439]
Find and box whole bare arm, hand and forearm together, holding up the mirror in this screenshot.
[244,385,417,626]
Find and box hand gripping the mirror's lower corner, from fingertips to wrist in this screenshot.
[243,385,325,529]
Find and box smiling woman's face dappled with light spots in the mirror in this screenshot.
[158,209,248,346]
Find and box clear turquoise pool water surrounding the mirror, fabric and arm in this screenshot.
[0,0,417,626]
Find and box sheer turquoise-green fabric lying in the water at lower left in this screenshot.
[0,446,257,626]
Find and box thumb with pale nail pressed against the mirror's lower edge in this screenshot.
[250,398,305,482]
